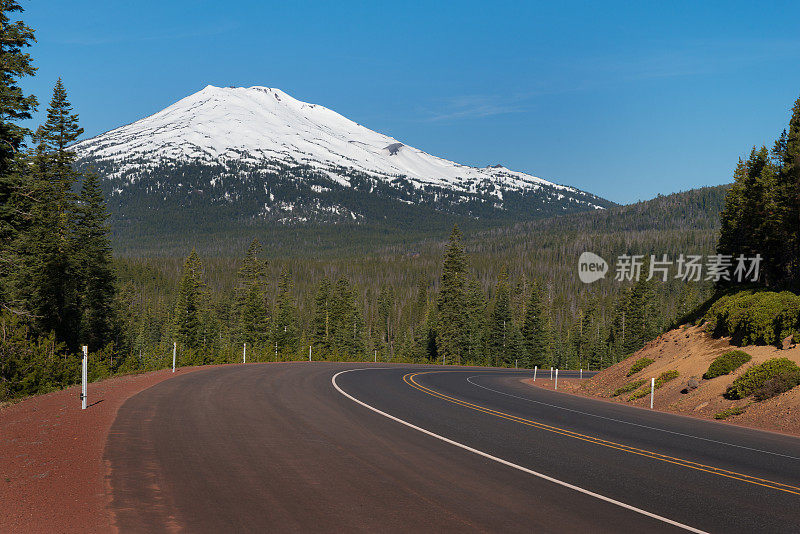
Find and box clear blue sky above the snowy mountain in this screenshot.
[21,0,800,203]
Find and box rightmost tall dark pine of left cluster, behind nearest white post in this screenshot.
[70,174,116,349]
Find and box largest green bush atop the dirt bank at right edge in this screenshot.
[703,290,800,346]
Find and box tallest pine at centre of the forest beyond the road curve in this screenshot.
[436,226,468,363]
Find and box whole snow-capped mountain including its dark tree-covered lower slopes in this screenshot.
[73,85,611,230]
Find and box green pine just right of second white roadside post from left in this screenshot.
[173,249,205,351]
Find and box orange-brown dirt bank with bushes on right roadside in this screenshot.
[524,326,800,435]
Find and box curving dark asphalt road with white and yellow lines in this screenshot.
[106,362,800,533]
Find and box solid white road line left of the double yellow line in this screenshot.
[331,367,708,534]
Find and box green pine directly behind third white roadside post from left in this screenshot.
[233,239,269,345]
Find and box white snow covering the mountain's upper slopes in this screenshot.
[73,85,603,203]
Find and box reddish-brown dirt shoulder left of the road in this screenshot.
[0,368,203,533]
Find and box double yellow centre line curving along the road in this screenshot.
[403,371,800,495]
